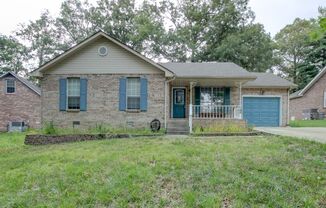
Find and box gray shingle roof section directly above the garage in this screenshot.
[243,72,296,88]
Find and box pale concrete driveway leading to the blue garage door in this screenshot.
[255,127,326,143]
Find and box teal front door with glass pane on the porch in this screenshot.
[173,88,186,118]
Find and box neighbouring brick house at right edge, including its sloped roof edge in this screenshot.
[290,67,326,119]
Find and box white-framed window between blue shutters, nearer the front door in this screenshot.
[127,77,140,110]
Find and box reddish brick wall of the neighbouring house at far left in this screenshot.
[0,77,41,131]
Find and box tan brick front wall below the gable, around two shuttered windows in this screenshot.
[41,74,165,128]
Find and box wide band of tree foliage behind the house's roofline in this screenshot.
[1,0,326,80]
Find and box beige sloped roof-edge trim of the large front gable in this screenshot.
[31,31,174,77]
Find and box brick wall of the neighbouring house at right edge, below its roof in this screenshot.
[290,74,326,119]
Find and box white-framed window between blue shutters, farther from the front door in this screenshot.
[67,78,80,110]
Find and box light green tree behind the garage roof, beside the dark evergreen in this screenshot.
[275,18,315,84]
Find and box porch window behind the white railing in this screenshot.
[200,87,224,112]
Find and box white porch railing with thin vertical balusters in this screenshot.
[189,104,241,119]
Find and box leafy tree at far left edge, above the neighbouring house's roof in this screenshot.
[0,34,28,74]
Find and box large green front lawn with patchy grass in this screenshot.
[0,134,326,207]
